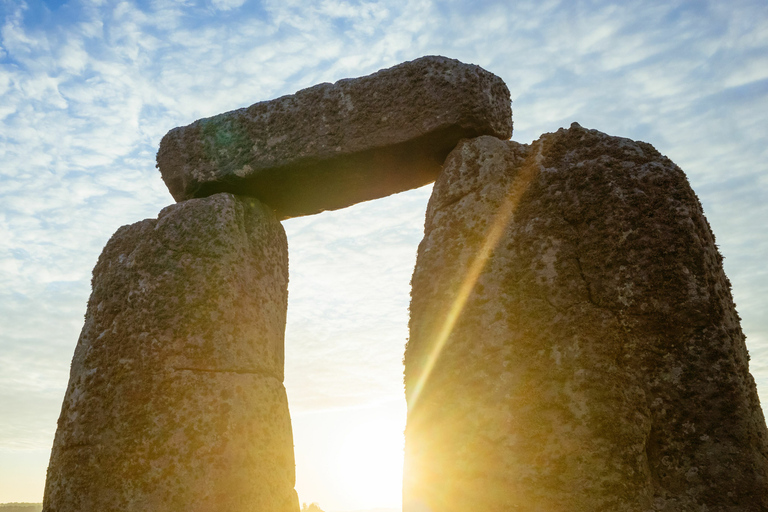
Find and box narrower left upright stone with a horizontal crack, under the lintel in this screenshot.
[44,194,298,512]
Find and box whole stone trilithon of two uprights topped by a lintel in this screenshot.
[44,57,768,512]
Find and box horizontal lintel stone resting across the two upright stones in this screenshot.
[157,56,512,219]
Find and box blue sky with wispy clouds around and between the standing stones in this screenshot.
[0,0,768,512]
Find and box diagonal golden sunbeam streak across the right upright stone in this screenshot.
[408,153,542,411]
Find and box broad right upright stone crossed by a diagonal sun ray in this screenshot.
[403,124,768,512]
